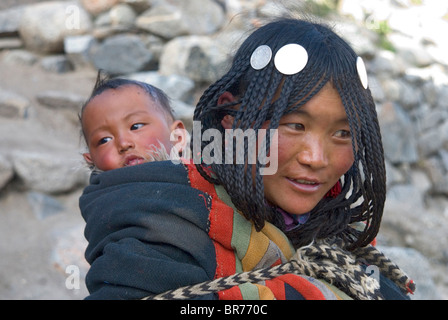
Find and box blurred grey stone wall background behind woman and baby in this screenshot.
[0,0,448,300]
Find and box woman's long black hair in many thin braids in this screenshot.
[192,18,386,250]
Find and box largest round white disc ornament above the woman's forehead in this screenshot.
[274,43,308,75]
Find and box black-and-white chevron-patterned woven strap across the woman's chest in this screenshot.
[143,238,415,300]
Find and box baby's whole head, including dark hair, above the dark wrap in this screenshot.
[80,74,186,171]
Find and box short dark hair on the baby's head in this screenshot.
[79,70,175,141]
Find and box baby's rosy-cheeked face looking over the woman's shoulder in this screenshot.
[82,85,183,171]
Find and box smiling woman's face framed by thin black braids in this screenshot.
[263,83,354,215]
